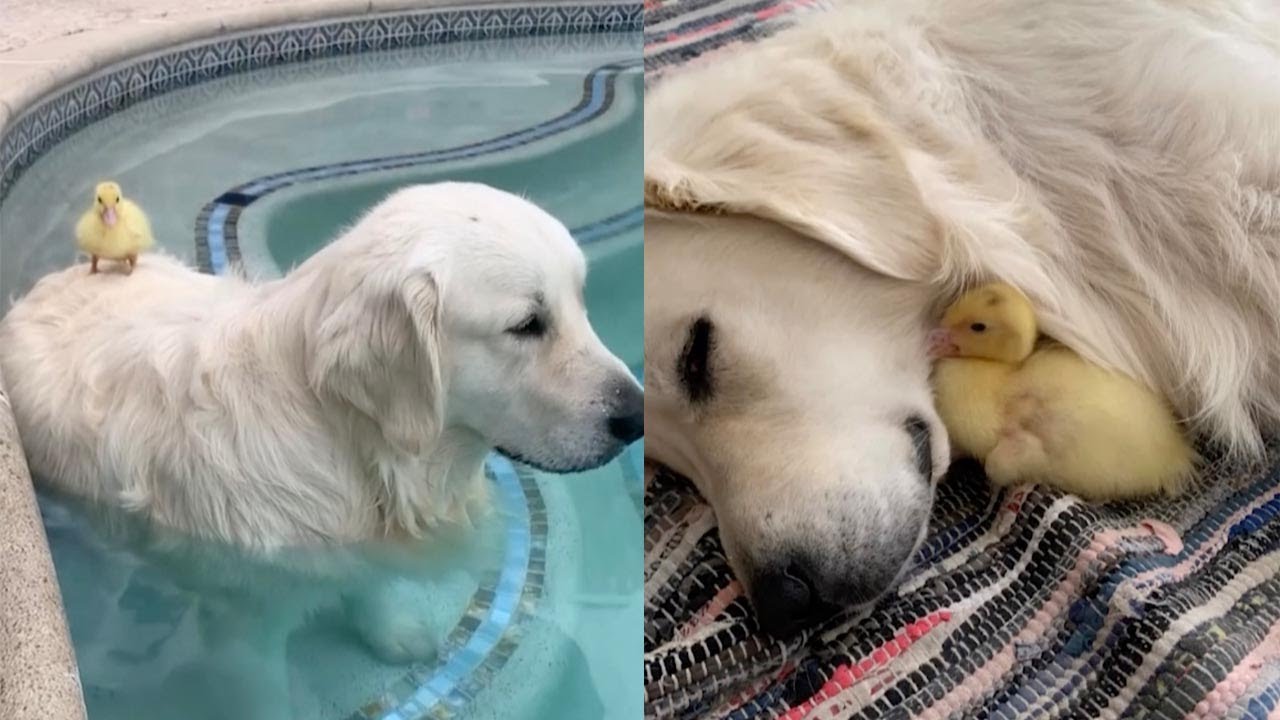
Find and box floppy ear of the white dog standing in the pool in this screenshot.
[307,273,444,455]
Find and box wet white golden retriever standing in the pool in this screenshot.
[0,183,644,660]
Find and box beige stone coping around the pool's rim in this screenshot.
[0,0,624,720]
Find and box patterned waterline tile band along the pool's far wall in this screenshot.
[0,3,643,202]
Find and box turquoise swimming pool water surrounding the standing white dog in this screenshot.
[0,11,643,720]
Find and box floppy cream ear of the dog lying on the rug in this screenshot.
[645,99,942,281]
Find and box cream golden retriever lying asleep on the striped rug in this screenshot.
[645,0,1280,630]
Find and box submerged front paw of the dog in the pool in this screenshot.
[347,582,436,665]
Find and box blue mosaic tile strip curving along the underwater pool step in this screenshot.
[186,49,644,720]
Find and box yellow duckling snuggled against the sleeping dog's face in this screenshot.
[929,283,1197,500]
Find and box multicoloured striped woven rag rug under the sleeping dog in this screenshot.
[644,0,1280,720]
